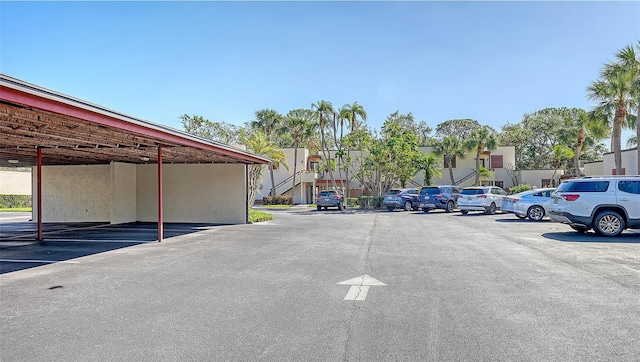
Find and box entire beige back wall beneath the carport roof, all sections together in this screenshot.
[32,163,247,224]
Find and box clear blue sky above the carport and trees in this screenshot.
[0,2,640,140]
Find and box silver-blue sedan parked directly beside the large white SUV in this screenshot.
[500,188,555,221]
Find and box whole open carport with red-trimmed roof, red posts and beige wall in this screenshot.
[0,74,269,241]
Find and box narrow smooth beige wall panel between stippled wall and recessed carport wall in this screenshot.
[110,162,138,224]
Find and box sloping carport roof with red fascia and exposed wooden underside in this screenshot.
[0,74,269,167]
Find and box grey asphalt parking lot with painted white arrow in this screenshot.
[0,207,640,361]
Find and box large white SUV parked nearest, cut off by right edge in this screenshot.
[549,176,640,236]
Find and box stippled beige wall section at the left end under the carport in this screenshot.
[32,165,112,222]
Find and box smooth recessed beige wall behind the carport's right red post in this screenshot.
[136,164,247,224]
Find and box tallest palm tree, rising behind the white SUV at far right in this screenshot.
[587,51,637,175]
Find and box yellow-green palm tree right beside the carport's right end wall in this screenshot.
[243,130,289,208]
